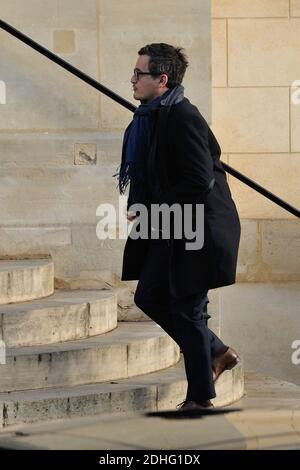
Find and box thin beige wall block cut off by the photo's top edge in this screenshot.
[212,0,289,18]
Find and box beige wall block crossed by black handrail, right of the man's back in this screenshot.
[229,154,300,219]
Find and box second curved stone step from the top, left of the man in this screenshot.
[0,290,117,347]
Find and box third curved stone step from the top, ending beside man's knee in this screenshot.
[0,322,179,392]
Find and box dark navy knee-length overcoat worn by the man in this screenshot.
[121,98,241,296]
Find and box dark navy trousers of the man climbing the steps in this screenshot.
[134,240,225,402]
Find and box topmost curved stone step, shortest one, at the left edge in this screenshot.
[0,258,54,304]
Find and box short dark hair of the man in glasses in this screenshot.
[138,42,188,88]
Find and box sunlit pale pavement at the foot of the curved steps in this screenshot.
[0,373,300,450]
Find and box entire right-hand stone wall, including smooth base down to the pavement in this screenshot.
[212,0,300,384]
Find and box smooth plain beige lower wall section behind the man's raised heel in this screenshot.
[221,282,300,383]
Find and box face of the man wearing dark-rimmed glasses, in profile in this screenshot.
[130,55,168,102]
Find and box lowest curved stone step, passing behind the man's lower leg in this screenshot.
[0,358,244,426]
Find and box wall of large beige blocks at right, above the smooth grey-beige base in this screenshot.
[212,0,300,281]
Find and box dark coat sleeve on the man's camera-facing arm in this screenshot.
[161,107,215,205]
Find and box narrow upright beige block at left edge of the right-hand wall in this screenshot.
[212,20,227,86]
